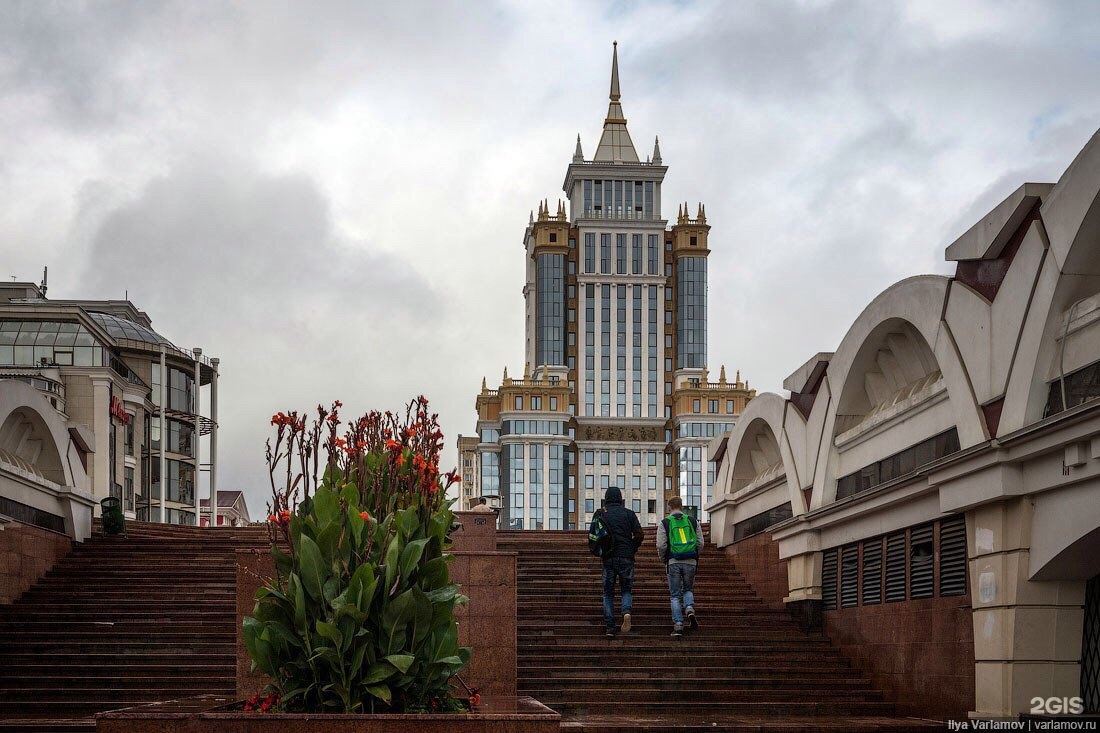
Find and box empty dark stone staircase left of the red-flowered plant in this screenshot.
[0,523,267,732]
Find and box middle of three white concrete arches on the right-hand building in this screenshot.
[811,275,987,508]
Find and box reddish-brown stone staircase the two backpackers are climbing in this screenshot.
[497,525,941,733]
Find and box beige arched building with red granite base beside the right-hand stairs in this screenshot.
[708,128,1100,716]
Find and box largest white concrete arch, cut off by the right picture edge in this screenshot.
[999,131,1100,435]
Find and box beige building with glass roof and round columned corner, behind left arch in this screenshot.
[0,277,219,525]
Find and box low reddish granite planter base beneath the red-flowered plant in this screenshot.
[96,696,561,733]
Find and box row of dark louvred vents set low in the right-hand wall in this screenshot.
[822,515,967,611]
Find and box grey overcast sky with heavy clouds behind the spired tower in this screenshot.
[0,0,1100,516]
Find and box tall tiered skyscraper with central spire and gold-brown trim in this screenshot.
[460,46,755,529]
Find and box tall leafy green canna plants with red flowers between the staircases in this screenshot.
[243,397,476,713]
